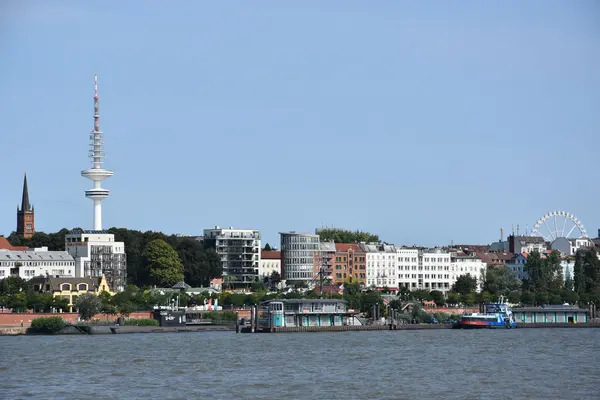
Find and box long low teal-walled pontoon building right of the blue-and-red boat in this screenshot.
[512,304,590,324]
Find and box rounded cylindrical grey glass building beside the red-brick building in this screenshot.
[279,231,323,285]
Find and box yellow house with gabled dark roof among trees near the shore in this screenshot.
[31,276,114,312]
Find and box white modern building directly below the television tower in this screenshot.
[65,230,127,292]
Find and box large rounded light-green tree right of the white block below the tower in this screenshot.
[144,239,184,287]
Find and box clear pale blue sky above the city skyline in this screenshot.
[0,0,600,245]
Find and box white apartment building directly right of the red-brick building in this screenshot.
[360,243,398,291]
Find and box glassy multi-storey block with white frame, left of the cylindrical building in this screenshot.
[204,226,261,289]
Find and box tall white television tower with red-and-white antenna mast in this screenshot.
[81,74,113,231]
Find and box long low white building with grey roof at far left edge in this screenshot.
[0,247,75,280]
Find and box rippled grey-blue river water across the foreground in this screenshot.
[0,329,600,399]
